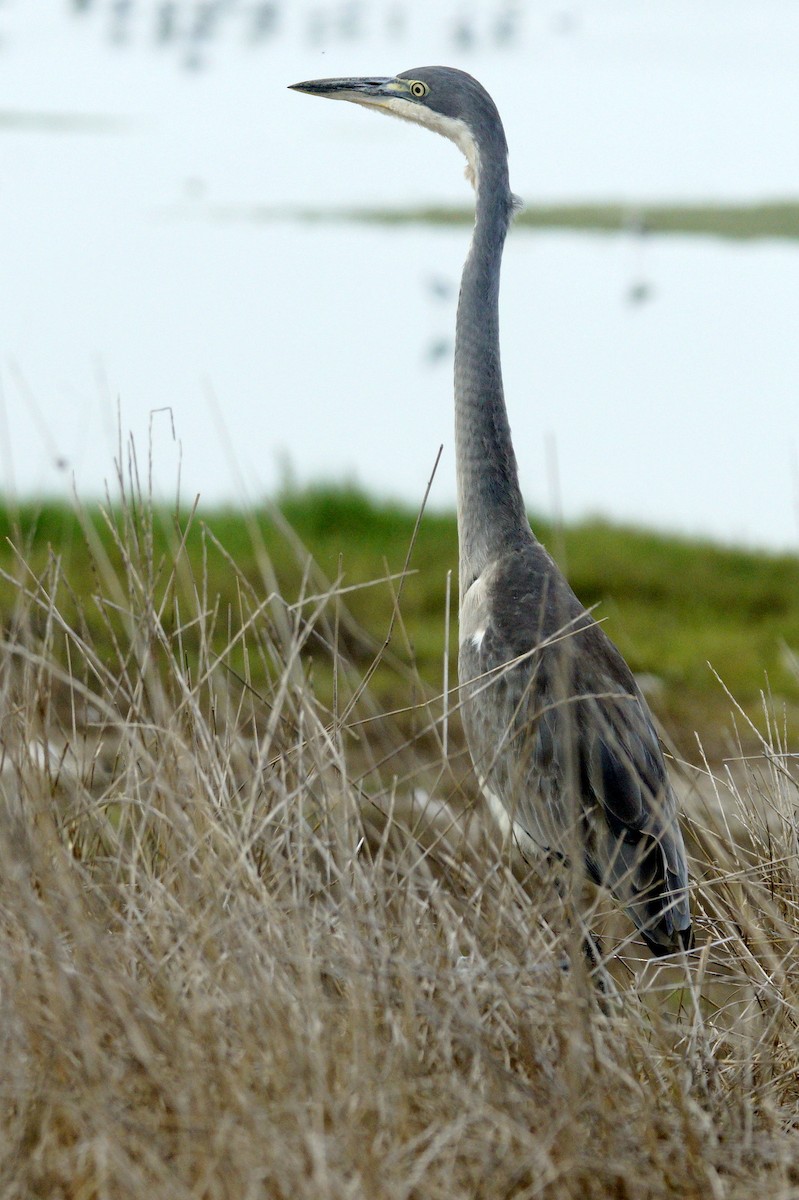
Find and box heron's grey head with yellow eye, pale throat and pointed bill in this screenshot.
[292,67,507,186]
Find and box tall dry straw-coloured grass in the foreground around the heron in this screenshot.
[0,463,799,1200]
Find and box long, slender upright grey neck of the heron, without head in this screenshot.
[455,158,530,596]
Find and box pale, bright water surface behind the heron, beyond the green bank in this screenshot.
[0,0,799,547]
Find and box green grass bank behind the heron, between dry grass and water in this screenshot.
[0,486,799,758]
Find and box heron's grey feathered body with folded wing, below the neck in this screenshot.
[458,540,691,954]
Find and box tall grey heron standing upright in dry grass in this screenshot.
[290,66,693,956]
